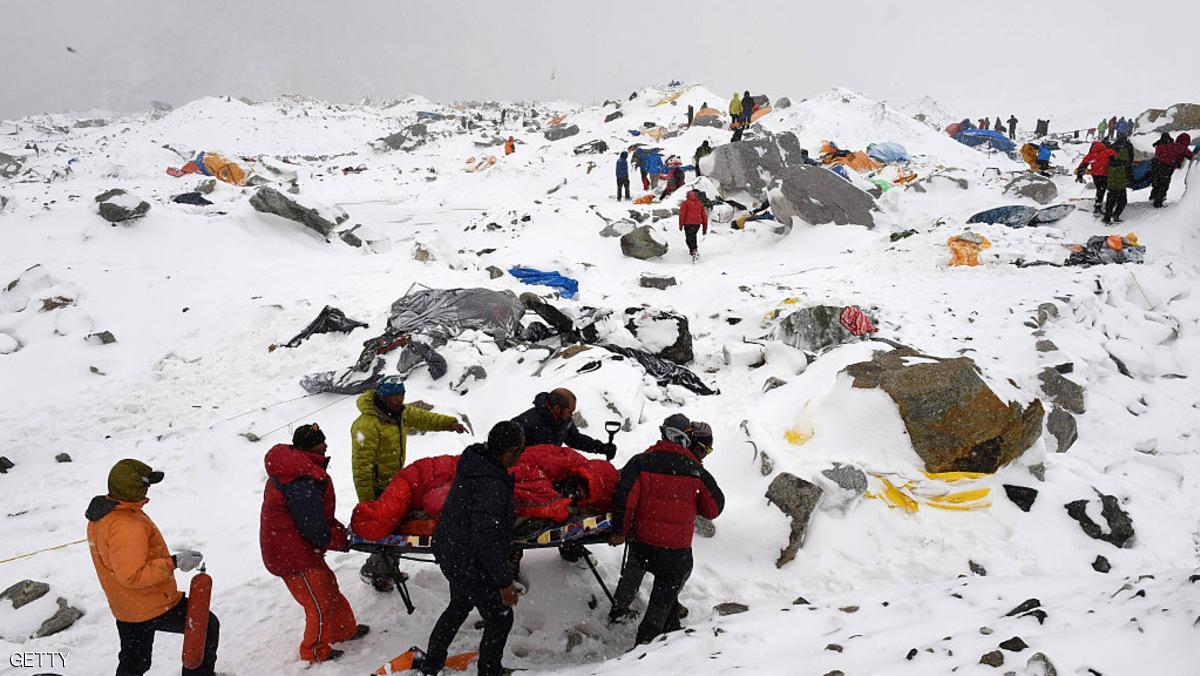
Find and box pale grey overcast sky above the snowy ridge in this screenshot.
[0,0,1200,125]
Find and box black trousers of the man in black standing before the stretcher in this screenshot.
[421,567,512,676]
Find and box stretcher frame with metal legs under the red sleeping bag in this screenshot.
[349,513,612,615]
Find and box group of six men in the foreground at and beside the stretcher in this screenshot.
[86,378,725,676]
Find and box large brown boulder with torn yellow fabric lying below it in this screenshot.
[846,347,1044,473]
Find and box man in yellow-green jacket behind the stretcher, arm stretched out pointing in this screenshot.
[350,378,467,592]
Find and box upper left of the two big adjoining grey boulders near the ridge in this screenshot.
[708,132,803,196]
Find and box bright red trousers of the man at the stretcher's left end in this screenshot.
[283,562,358,662]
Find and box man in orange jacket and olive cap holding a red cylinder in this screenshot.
[85,460,221,676]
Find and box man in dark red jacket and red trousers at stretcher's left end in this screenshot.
[259,423,371,663]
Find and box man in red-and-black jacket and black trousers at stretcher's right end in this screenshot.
[608,413,725,644]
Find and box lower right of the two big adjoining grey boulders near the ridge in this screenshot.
[769,164,875,228]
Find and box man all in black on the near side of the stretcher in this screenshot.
[414,420,524,676]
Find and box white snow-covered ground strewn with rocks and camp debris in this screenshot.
[0,86,1200,676]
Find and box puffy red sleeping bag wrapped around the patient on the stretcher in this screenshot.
[350,444,618,540]
